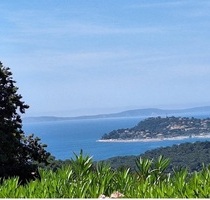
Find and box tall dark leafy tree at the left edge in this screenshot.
[0,62,50,184]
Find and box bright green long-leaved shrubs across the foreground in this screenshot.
[0,152,210,198]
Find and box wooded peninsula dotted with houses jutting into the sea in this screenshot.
[98,116,210,142]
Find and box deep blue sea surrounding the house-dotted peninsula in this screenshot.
[23,115,210,161]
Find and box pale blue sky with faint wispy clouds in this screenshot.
[0,0,210,116]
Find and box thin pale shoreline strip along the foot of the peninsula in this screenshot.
[96,134,210,143]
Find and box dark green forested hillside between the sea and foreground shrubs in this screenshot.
[105,141,210,171]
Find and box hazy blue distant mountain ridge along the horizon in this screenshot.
[23,106,210,122]
